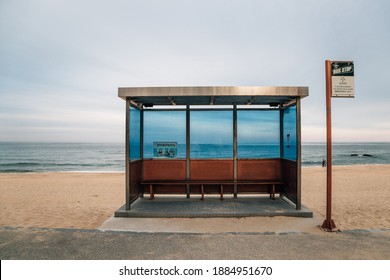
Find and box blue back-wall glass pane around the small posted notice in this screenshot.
[144,111,186,158]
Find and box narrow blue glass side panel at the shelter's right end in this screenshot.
[283,106,297,161]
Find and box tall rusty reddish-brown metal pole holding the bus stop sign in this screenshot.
[322,60,336,231]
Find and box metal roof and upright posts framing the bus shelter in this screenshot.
[118,87,308,210]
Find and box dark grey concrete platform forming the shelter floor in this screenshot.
[115,196,313,218]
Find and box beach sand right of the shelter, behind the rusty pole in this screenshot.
[302,165,390,230]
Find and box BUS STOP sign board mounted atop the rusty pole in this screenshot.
[331,61,355,97]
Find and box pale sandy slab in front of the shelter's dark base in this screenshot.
[98,215,324,234]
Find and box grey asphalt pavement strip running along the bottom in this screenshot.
[0,226,390,260]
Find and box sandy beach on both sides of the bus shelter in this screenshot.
[0,165,390,231]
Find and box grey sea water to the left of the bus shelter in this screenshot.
[0,142,124,173]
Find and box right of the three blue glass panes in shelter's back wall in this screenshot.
[237,110,280,158]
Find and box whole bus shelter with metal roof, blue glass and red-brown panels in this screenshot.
[118,87,308,215]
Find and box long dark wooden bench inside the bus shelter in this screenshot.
[140,180,284,200]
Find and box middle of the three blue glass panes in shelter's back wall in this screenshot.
[190,111,233,158]
